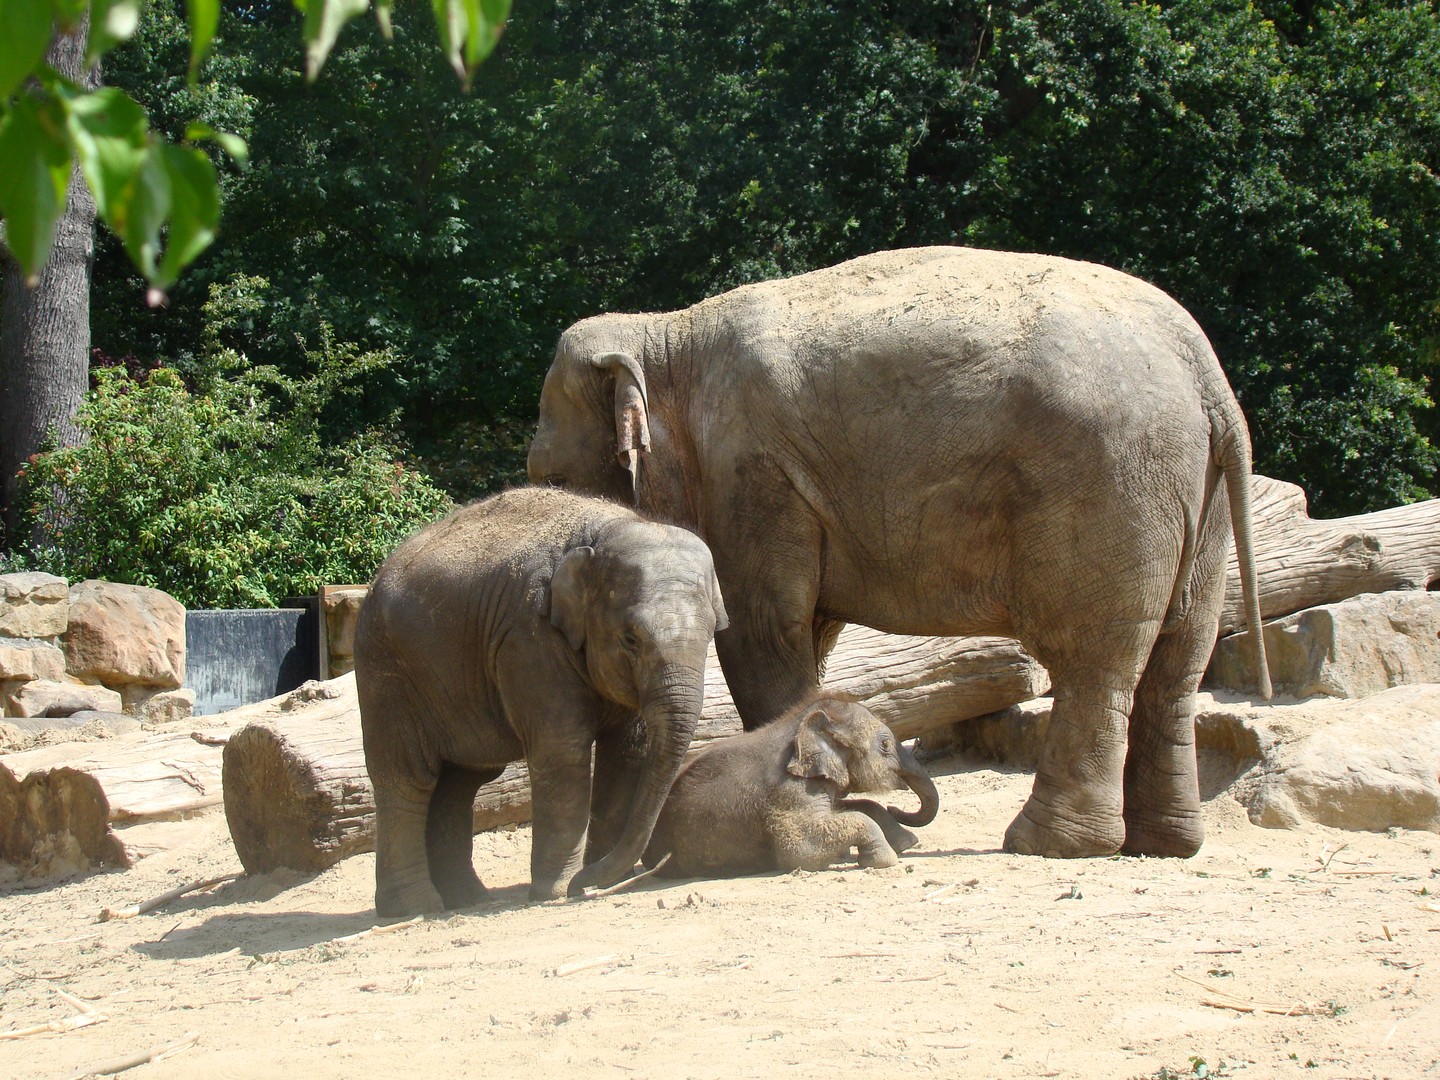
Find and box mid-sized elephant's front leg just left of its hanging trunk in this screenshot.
[528,743,590,900]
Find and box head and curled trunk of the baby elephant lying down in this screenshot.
[785,696,940,827]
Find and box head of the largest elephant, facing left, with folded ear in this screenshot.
[526,315,651,503]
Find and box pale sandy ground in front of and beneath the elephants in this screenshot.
[0,760,1440,1080]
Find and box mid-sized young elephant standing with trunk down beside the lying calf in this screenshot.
[356,488,726,916]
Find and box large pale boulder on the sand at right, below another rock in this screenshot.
[1195,684,1440,832]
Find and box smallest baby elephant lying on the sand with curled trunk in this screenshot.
[645,693,940,877]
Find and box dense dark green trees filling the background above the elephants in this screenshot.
[87,0,1440,513]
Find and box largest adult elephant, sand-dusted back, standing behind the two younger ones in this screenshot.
[528,248,1269,857]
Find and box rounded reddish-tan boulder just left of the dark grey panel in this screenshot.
[65,582,184,690]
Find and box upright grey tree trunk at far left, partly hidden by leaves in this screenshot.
[0,23,98,547]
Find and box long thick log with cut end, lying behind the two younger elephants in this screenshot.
[223,626,1048,873]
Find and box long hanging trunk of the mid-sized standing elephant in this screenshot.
[569,664,704,896]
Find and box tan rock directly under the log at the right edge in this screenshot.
[1205,592,1440,698]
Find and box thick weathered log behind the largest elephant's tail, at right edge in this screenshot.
[1220,475,1440,635]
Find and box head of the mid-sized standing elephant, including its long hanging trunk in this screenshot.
[550,518,729,896]
